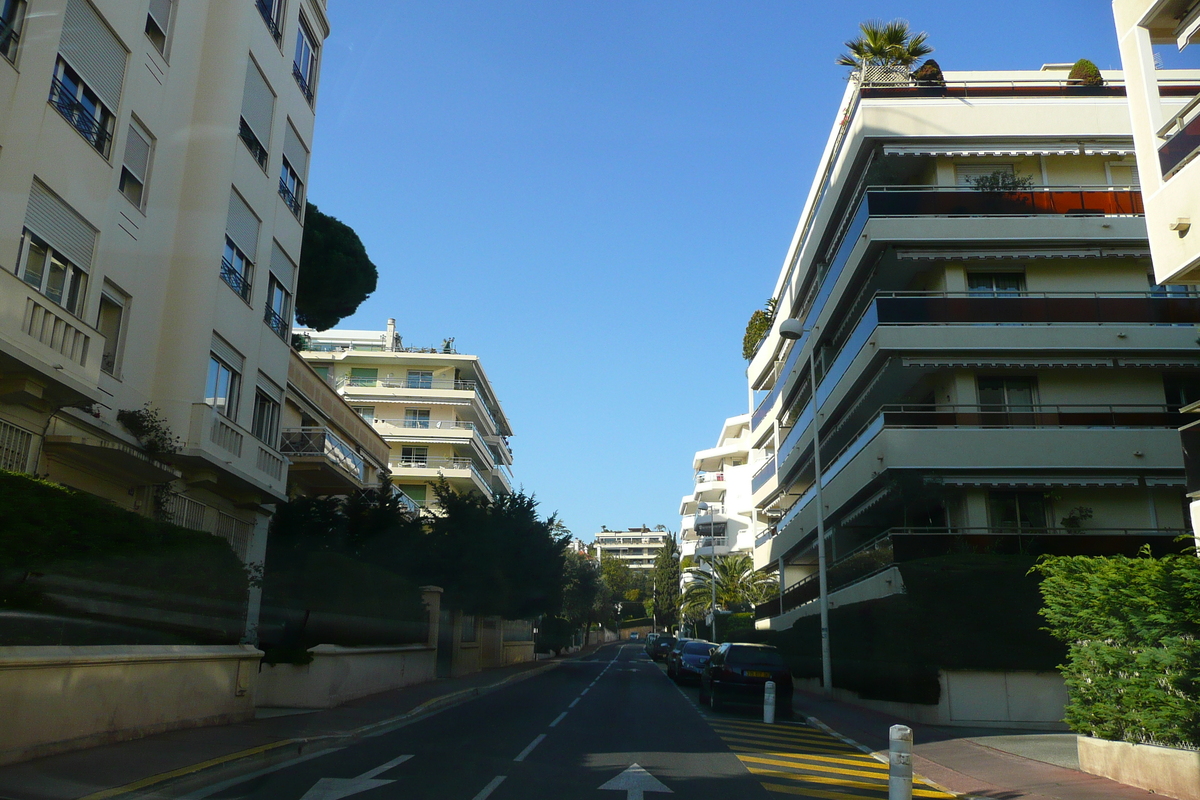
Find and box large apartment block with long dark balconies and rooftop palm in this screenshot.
[748,65,1200,628]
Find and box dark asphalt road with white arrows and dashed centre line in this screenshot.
[190,644,769,800]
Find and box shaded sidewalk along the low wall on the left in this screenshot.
[0,645,609,800]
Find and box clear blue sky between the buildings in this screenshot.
[308,0,1166,540]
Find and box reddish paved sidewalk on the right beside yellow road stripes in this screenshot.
[794,691,1162,800]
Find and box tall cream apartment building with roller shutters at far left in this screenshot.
[0,0,329,594]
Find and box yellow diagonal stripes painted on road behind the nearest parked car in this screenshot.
[708,717,954,800]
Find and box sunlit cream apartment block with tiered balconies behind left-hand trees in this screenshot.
[298,319,512,506]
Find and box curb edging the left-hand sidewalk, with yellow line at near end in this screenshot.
[78,660,563,800]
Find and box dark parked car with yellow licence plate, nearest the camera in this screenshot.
[700,643,792,717]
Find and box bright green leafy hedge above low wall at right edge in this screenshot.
[1037,555,1200,746]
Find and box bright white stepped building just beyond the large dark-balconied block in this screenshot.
[679,414,756,558]
